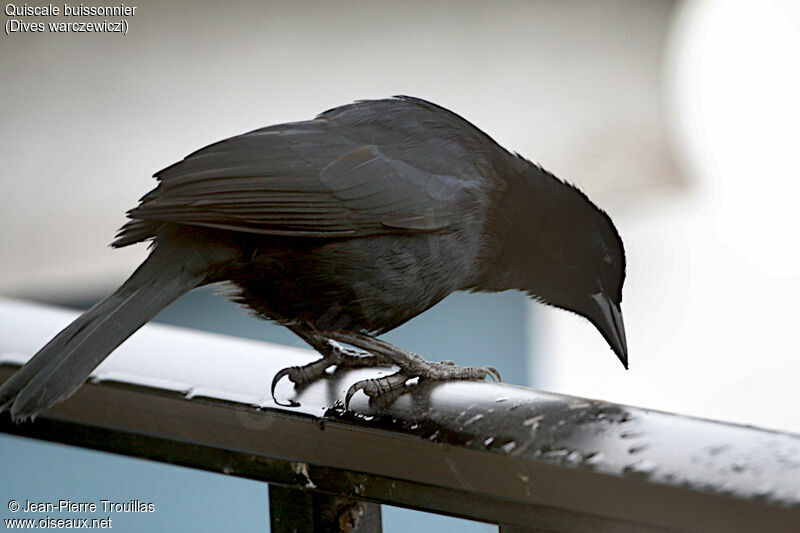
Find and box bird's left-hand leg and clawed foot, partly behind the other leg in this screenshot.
[272,326,392,398]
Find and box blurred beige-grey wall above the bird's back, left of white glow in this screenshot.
[0,0,677,298]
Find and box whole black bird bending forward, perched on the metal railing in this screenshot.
[0,96,628,420]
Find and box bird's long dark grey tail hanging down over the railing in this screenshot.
[0,241,208,421]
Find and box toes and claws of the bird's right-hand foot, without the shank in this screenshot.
[344,361,501,409]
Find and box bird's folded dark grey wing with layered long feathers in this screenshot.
[123,119,471,237]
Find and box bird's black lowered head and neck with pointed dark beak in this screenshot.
[479,161,628,369]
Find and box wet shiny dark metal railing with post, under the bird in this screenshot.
[0,300,800,532]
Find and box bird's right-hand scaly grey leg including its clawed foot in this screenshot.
[326,331,500,407]
